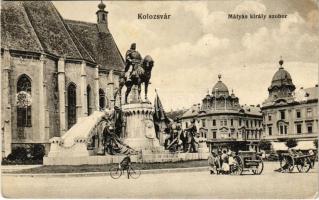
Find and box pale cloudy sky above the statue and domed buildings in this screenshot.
[54,0,319,111]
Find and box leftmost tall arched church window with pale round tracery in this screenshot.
[17,75,32,127]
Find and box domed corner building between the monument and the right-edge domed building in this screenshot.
[181,75,262,150]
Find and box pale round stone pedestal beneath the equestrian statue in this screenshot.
[122,103,160,150]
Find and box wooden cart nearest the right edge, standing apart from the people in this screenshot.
[277,150,316,173]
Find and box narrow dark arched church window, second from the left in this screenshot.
[67,83,76,129]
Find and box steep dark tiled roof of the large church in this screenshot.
[1,1,124,71]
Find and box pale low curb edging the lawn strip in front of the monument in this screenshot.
[1,167,208,177]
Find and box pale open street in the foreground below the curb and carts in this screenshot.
[2,163,318,198]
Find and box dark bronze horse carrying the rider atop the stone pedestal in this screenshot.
[115,55,154,104]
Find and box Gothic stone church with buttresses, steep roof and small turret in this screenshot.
[1,1,124,156]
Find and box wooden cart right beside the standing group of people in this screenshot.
[231,151,264,175]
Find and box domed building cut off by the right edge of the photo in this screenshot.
[261,60,318,141]
